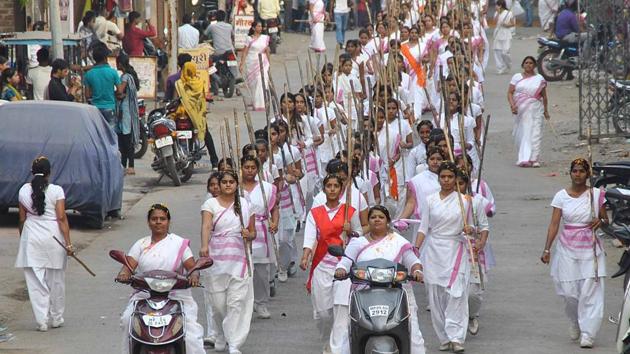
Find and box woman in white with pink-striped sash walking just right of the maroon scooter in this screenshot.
[199,171,256,354]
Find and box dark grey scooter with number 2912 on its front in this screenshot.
[328,246,411,354]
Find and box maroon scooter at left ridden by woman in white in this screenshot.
[109,251,213,354]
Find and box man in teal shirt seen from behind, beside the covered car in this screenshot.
[84,45,124,129]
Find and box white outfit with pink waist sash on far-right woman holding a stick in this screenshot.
[551,188,606,340]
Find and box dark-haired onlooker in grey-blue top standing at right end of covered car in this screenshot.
[116,54,140,175]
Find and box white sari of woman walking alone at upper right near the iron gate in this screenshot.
[510,74,547,166]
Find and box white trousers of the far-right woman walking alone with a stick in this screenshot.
[554,277,604,339]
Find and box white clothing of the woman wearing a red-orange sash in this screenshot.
[304,202,361,354]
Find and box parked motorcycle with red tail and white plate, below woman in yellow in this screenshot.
[147,99,194,186]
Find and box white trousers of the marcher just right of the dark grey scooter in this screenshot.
[426,284,468,344]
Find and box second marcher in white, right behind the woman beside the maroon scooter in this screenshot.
[241,155,280,319]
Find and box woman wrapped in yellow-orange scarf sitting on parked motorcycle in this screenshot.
[175,62,219,169]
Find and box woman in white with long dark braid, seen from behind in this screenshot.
[15,156,74,332]
